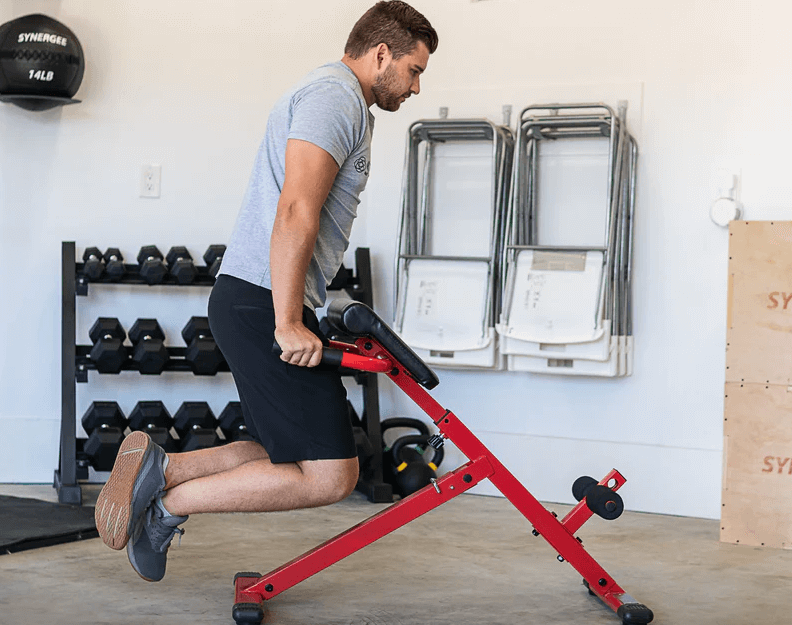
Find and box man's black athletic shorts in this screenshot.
[209,275,357,462]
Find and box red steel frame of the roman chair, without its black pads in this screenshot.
[234,338,635,611]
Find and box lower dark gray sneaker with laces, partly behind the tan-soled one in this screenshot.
[127,503,188,582]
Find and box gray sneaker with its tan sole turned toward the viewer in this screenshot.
[94,432,168,549]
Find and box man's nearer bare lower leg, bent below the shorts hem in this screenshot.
[162,455,358,516]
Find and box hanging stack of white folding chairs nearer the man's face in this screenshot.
[394,119,513,369]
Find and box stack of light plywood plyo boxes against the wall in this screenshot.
[721,221,792,549]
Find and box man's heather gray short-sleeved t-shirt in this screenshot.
[219,61,374,309]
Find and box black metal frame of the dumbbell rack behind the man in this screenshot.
[53,241,393,506]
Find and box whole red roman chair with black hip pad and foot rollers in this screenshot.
[233,299,654,625]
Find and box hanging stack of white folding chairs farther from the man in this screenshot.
[497,104,638,377]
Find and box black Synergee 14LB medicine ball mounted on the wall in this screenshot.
[0,14,85,111]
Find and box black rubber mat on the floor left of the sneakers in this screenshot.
[0,495,99,555]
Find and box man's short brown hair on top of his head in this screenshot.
[344,0,438,59]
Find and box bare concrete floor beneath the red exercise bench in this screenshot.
[0,485,792,625]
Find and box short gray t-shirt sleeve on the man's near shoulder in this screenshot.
[289,82,363,167]
